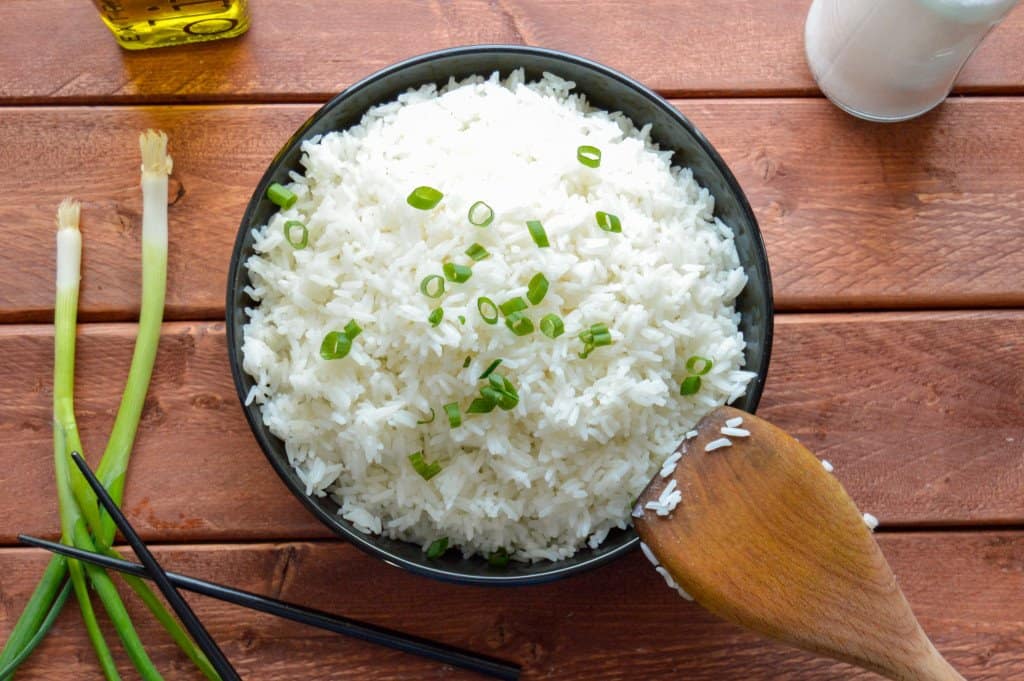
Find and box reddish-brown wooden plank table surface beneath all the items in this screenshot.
[0,0,1024,681]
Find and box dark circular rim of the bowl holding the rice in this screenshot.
[224,44,775,586]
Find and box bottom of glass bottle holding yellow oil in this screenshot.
[93,0,249,49]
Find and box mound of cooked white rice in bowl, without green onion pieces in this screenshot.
[243,72,753,561]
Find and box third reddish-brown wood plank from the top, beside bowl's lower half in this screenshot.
[0,311,1024,544]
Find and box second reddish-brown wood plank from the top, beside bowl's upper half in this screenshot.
[0,98,1024,322]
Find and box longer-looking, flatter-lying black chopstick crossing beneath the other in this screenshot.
[17,535,520,681]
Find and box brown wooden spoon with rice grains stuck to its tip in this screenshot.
[634,407,964,681]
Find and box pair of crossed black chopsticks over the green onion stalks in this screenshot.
[18,453,520,681]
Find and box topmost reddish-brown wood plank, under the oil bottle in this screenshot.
[0,0,1024,103]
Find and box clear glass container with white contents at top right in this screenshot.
[804,0,1018,122]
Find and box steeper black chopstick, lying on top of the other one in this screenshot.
[71,452,242,681]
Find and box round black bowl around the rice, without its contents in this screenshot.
[227,45,772,585]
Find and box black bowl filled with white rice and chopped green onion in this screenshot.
[226,46,772,584]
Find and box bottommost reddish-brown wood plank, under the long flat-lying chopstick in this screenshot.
[0,533,1024,681]
